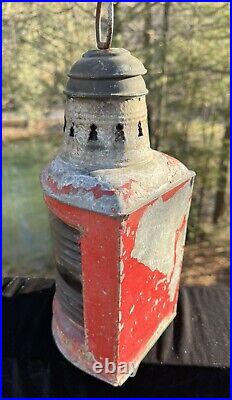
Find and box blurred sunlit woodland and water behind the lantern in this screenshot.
[3,2,229,285]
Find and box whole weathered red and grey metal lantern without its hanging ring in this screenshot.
[41,49,194,385]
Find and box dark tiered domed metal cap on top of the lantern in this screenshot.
[65,48,147,98]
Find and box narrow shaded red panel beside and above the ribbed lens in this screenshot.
[45,196,120,361]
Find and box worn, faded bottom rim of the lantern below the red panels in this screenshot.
[52,296,176,386]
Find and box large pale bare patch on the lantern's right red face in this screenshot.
[132,184,190,277]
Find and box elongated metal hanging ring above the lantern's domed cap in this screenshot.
[96,2,114,50]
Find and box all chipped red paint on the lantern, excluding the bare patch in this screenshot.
[45,181,191,382]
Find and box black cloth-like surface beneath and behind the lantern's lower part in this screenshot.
[3,278,229,398]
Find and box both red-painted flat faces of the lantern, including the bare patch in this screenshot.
[45,177,192,382]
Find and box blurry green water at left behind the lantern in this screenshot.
[3,135,60,276]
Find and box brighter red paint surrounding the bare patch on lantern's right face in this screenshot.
[118,182,187,362]
